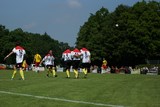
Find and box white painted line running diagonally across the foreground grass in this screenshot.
[0,91,124,107]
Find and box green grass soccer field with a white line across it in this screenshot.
[0,70,160,107]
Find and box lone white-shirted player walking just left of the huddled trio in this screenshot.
[40,50,57,77]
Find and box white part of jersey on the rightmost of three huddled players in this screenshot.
[81,51,91,63]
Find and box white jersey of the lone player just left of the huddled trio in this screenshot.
[42,54,55,65]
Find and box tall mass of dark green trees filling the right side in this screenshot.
[76,1,160,65]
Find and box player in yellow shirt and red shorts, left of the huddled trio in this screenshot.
[33,53,42,72]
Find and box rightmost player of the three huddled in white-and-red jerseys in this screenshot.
[80,48,91,78]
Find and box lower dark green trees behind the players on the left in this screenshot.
[0,25,70,64]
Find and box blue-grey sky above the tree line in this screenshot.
[0,0,152,46]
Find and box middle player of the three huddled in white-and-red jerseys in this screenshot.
[71,48,81,79]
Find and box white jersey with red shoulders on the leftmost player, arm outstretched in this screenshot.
[12,46,26,63]
